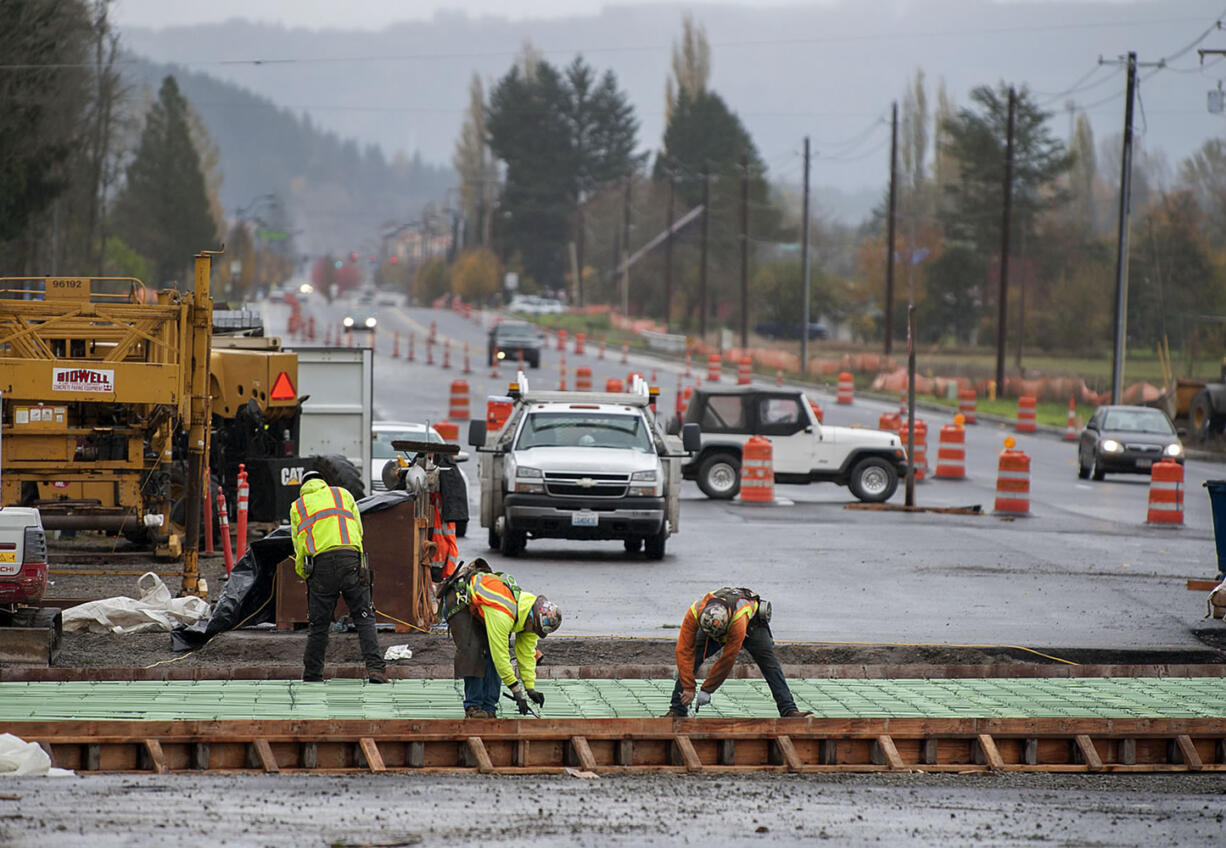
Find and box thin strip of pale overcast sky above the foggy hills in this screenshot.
[114,0,843,29]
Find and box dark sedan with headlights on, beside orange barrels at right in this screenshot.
[1076,406,1183,480]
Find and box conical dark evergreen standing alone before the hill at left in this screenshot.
[114,76,217,288]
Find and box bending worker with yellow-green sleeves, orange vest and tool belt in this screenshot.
[439,558,562,718]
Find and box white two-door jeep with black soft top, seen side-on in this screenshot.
[682,386,907,504]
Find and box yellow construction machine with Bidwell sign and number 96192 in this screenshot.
[0,251,213,593]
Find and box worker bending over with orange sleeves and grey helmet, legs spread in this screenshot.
[666,587,813,718]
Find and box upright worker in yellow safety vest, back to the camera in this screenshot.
[289,471,387,683]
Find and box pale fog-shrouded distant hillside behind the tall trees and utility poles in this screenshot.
[123,0,1226,226]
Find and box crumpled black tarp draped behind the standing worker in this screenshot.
[170,491,413,651]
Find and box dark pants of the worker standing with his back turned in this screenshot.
[303,550,385,680]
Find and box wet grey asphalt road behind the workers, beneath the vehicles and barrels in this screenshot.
[281,303,1226,651]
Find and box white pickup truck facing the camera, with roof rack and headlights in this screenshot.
[468,373,700,560]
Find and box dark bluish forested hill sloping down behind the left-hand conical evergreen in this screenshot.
[124,58,455,254]
